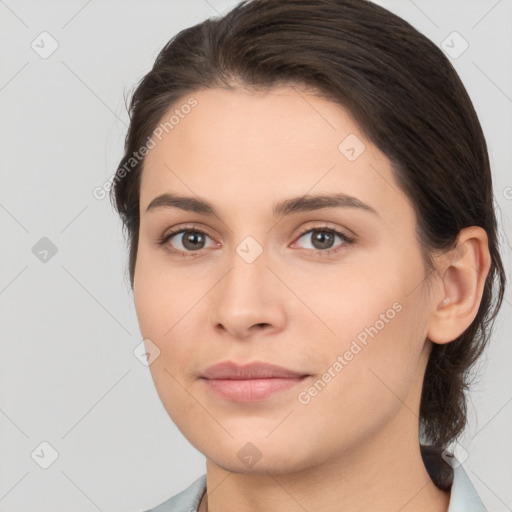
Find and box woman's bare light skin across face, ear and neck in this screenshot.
[134,86,490,512]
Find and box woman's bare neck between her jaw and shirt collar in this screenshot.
[199,411,450,512]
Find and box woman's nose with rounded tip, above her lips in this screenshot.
[208,246,289,340]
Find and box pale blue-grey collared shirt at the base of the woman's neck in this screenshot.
[145,449,488,512]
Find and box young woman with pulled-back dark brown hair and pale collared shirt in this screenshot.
[112,0,505,512]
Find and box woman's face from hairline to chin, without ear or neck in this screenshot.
[134,87,433,473]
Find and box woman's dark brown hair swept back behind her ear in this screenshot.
[111,0,506,454]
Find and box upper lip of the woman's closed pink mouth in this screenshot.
[201,361,306,380]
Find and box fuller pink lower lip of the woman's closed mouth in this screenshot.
[203,376,306,402]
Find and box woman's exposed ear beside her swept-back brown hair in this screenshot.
[427,226,491,344]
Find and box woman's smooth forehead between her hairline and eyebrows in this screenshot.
[140,86,412,225]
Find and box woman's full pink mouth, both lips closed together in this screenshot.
[201,361,309,402]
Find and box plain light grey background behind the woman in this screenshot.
[0,0,512,512]
